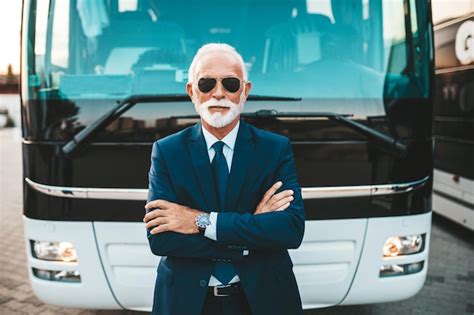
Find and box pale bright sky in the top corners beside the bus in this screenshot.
[0,0,474,74]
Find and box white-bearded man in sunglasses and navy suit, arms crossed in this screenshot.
[144,44,304,315]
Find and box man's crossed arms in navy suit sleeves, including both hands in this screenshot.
[144,140,304,260]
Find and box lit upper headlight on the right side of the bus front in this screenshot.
[383,234,424,257]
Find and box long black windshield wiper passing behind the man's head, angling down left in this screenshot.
[62,94,301,156]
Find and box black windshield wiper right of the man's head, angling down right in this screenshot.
[241,109,407,158]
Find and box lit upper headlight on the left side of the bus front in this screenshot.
[31,240,77,262]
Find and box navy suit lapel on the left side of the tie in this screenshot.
[188,123,220,211]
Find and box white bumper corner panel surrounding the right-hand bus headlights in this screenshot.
[340,212,431,305]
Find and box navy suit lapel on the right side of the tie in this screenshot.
[224,120,255,210]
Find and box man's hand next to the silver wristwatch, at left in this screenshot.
[143,199,202,234]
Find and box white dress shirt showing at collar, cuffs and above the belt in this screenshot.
[201,121,243,286]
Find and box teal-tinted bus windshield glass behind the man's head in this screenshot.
[28,0,428,103]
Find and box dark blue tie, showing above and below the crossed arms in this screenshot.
[211,141,237,284]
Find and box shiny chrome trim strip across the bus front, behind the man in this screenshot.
[25,176,430,201]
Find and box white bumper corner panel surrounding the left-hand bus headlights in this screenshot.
[23,216,122,309]
